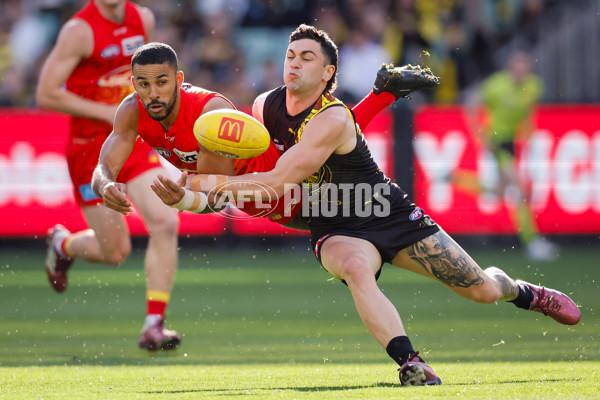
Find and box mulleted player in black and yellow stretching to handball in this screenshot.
[155,25,581,385]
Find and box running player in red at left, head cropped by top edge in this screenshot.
[37,0,180,350]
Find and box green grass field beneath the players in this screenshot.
[0,240,600,399]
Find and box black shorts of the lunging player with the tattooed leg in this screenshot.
[310,200,440,263]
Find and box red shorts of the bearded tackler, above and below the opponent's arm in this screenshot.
[234,142,302,225]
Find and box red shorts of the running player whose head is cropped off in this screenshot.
[66,136,161,207]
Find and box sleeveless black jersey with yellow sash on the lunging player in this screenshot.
[263,86,404,230]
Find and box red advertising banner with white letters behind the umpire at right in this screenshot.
[414,105,600,234]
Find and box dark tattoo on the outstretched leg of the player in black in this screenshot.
[408,233,484,288]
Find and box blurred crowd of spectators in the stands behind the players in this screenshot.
[0,0,592,106]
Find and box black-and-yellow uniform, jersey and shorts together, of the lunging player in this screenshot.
[263,86,439,262]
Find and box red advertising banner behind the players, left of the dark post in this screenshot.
[0,109,393,237]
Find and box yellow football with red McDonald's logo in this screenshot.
[194,109,271,158]
